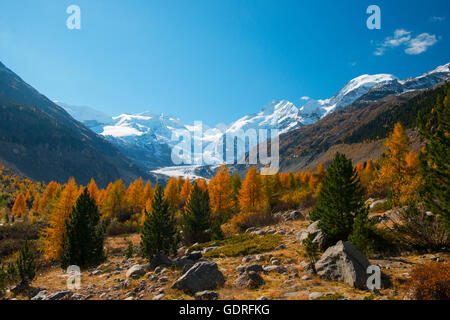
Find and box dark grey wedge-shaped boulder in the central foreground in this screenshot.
[172,261,225,294]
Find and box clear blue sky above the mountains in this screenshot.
[0,0,450,125]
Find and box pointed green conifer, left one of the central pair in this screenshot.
[140,183,178,259]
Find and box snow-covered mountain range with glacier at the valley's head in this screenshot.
[59,63,450,172]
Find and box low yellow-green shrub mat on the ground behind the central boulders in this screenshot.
[205,234,281,258]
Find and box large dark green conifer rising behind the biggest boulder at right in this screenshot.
[310,152,364,244]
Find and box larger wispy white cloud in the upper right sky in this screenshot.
[373,29,437,56]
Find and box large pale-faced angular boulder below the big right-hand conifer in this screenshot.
[315,241,370,289]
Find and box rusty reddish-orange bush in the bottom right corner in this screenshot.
[408,262,450,300]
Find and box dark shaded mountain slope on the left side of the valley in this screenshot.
[0,63,156,186]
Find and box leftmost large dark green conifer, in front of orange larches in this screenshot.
[61,188,105,269]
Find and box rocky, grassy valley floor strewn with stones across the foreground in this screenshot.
[7,212,449,300]
